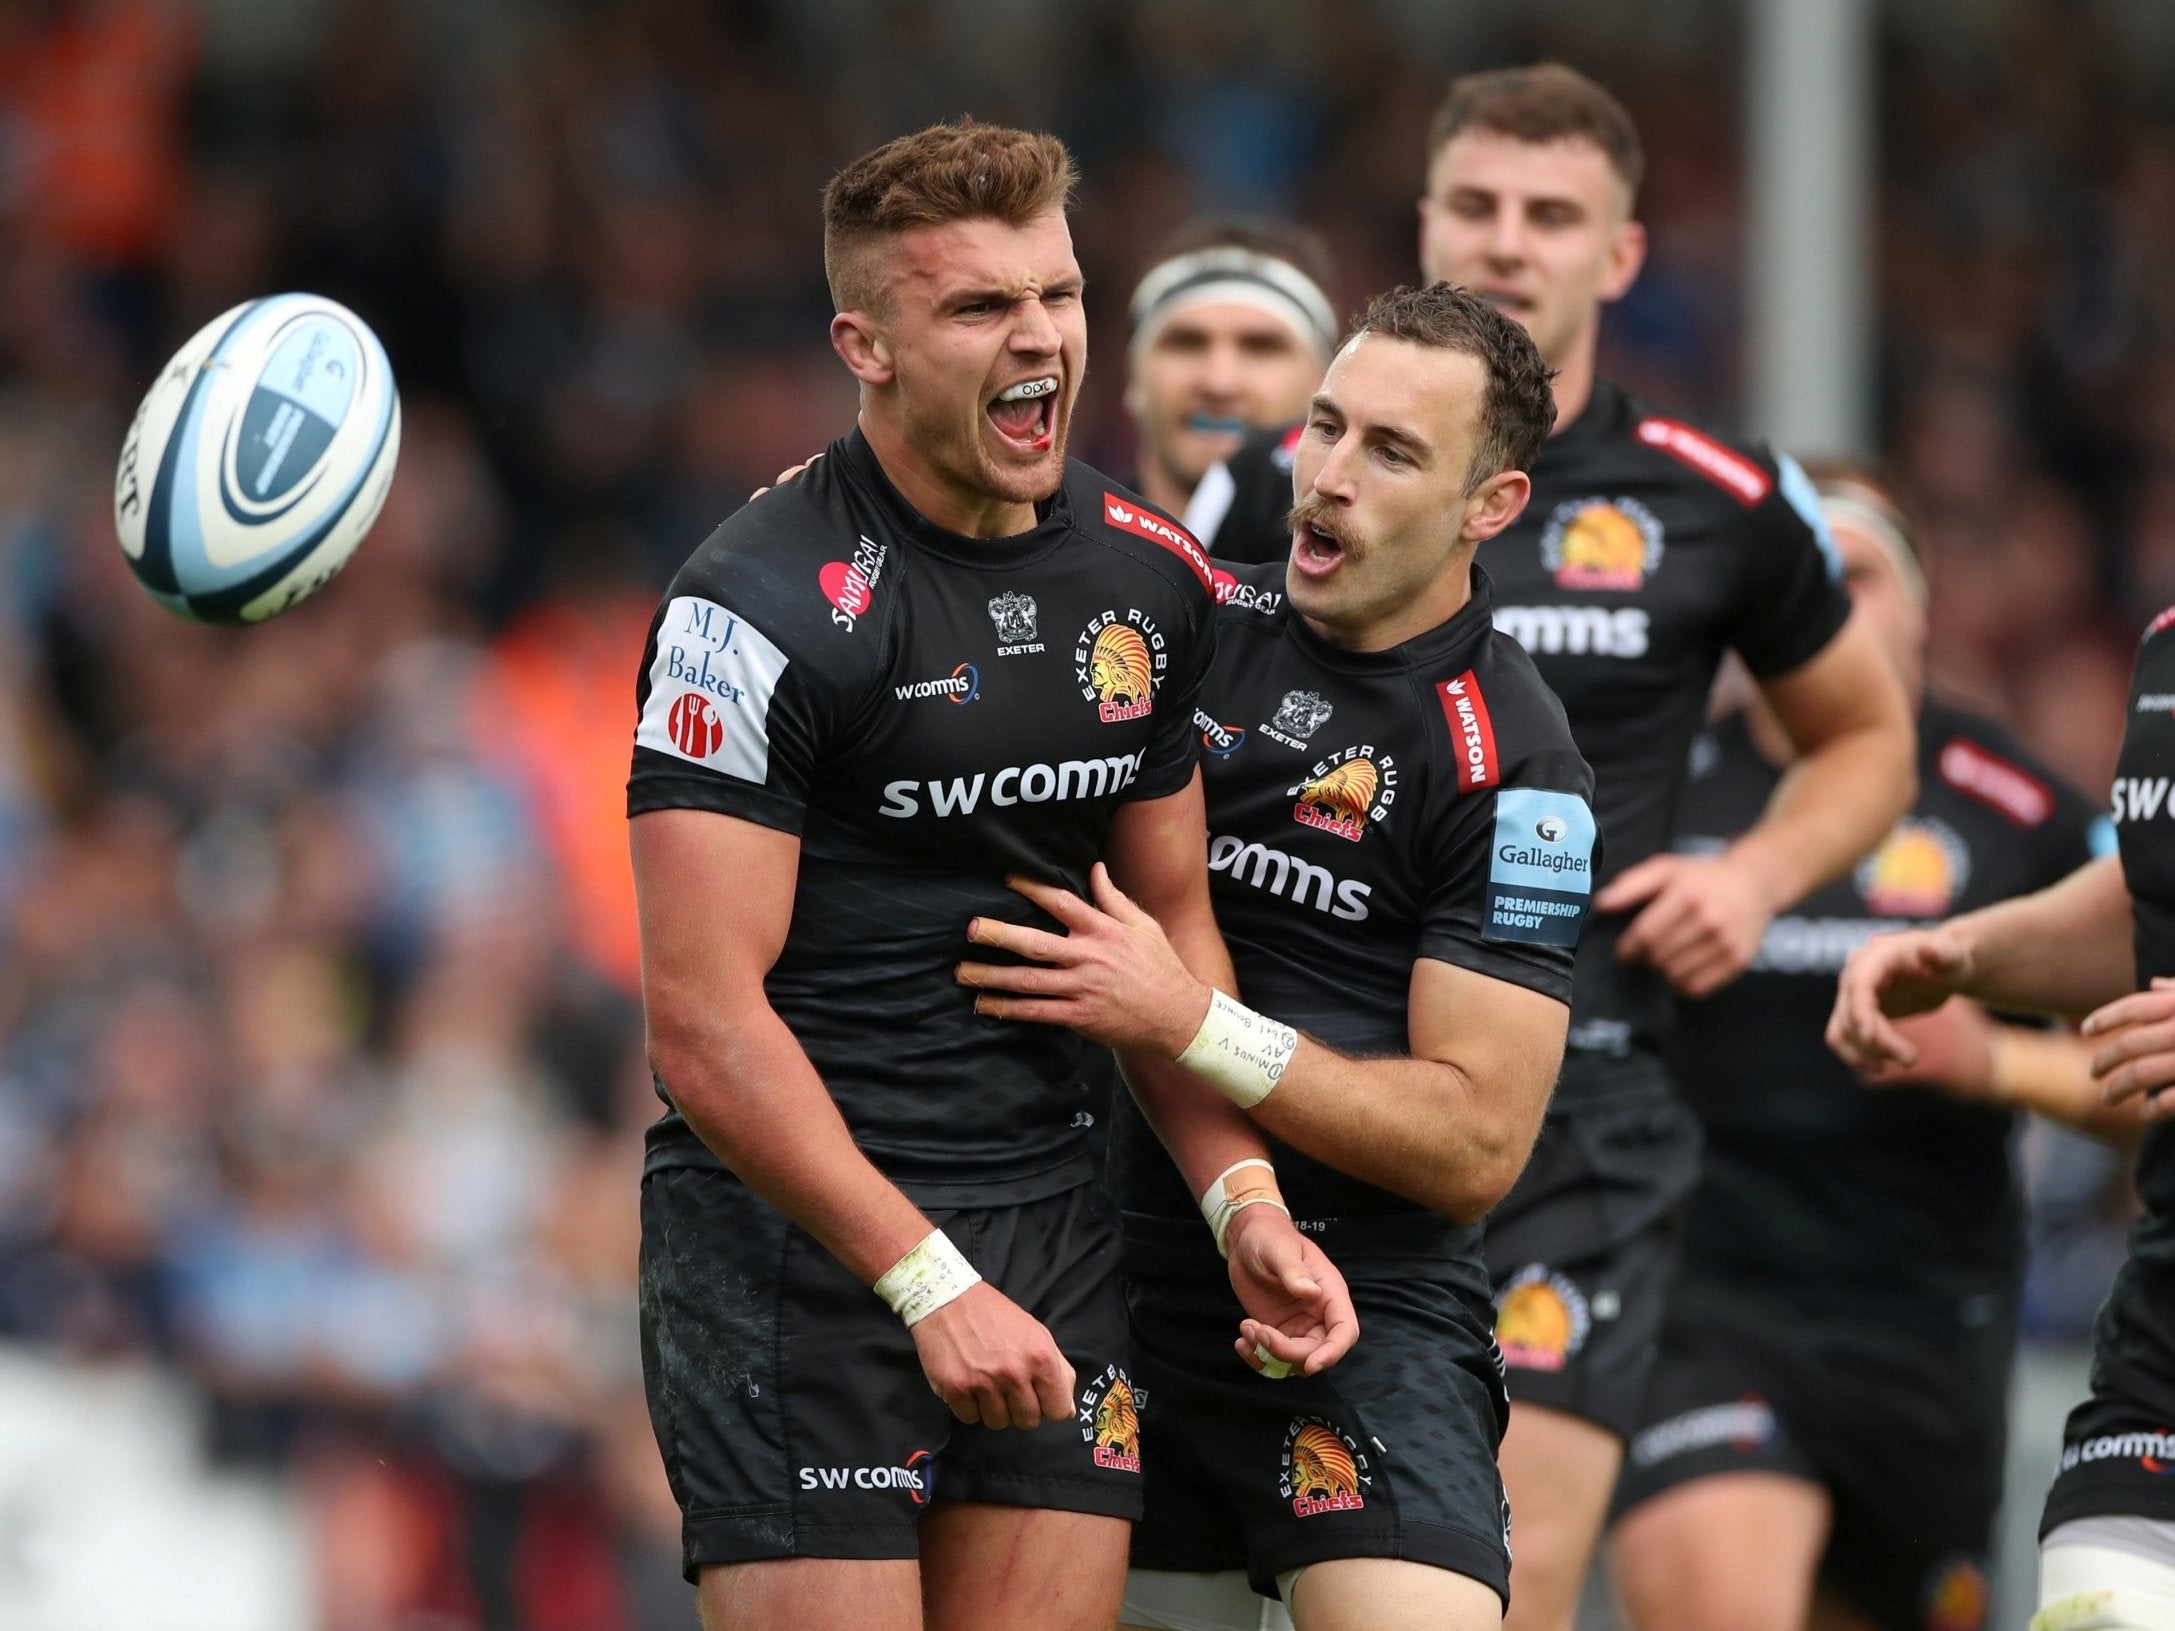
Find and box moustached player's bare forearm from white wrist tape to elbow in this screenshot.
[1253,1033,1564,1222]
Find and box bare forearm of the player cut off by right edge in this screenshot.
[1947,855,2138,1018]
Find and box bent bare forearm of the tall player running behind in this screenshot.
[1729,715,1916,913]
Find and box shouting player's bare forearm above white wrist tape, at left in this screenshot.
[650,1005,931,1285]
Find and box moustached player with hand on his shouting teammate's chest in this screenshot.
[959,283,1594,1631]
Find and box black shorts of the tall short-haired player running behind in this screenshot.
[1481,1053,1701,1437]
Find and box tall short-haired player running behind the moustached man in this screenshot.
[1203,63,1912,1631]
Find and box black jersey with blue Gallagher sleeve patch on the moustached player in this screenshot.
[1114,568,1594,1294]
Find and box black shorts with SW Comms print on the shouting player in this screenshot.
[639,1168,1142,1581]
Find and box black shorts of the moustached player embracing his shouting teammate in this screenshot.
[1127,1213,1509,1601]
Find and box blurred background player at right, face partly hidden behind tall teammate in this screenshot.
[1612,465,2114,1631]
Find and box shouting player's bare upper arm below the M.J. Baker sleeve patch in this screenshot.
[626,809,800,1026]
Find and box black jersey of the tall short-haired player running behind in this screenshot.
[1203,381,1851,1074]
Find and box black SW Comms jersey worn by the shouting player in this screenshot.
[629,431,1214,1205]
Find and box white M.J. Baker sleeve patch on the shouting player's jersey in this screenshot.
[635,594,790,785]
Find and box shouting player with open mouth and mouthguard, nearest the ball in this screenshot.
[629,124,1353,1631]
